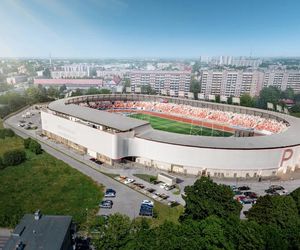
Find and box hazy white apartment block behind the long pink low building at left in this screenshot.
[51,64,90,79]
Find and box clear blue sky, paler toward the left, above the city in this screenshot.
[0,0,300,58]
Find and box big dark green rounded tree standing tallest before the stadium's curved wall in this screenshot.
[181,176,242,220]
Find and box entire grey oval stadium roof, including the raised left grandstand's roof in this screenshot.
[49,94,300,150]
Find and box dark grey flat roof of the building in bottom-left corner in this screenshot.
[4,214,72,250]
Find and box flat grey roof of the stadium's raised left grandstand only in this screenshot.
[48,99,149,131]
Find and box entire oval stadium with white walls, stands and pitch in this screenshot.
[41,94,300,178]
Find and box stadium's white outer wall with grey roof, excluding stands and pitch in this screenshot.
[41,94,300,178]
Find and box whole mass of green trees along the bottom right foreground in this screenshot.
[90,177,300,250]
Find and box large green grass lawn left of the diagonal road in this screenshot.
[0,137,103,227]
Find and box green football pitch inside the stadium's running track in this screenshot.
[128,114,232,137]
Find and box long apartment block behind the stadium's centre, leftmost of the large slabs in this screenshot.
[130,70,191,96]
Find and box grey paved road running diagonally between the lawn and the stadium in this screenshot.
[5,109,148,218]
